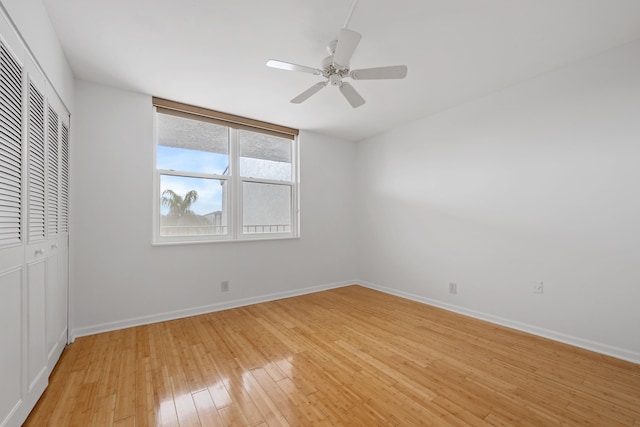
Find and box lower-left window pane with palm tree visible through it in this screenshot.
[159,175,228,237]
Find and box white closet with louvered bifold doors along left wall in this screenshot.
[0,13,70,427]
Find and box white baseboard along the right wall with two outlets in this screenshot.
[355,280,640,364]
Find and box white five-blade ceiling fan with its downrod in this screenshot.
[267,0,407,108]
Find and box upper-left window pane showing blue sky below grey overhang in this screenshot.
[156,113,229,175]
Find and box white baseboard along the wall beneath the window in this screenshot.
[69,281,356,343]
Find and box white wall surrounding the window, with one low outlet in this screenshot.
[71,81,355,335]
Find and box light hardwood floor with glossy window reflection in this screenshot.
[25,286,640,427]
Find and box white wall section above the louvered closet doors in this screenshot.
[1,0,74,109]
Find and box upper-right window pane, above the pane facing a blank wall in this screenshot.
[238,130,292,181]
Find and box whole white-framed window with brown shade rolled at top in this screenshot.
[153,98,299,243]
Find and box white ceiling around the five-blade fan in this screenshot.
[43,0,640,140]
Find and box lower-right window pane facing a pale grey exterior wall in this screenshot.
[242,182,291,234]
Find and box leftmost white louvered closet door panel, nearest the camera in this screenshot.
[0,37,24,425]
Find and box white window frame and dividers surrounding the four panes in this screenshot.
[152,98,300,245]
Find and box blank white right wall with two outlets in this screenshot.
[356,42,640,361]
